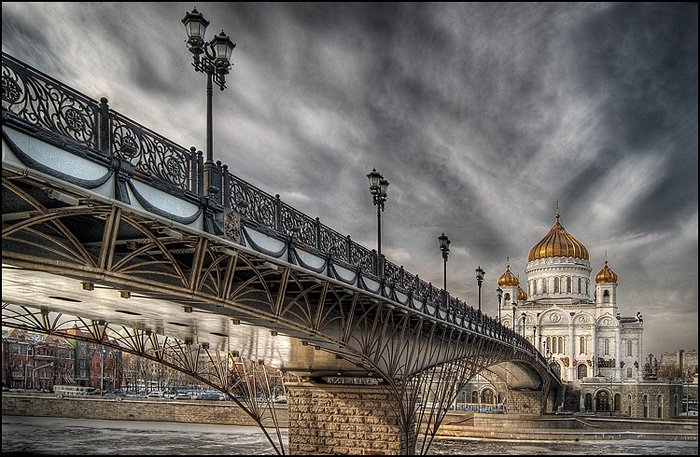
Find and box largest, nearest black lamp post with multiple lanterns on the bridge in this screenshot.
[182,8,236,193]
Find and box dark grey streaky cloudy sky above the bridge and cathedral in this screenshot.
[2,2,698,356]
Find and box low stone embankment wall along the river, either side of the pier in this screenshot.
[2,392,698,441]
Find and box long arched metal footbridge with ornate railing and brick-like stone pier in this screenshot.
[2,53,562,454]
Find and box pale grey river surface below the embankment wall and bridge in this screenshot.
[2,416,698,455]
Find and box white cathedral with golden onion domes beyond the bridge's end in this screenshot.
[498,211,645,383]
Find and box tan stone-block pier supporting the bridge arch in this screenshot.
[285,382,415,455]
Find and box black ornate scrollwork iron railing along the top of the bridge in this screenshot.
[2,53,520,345]
